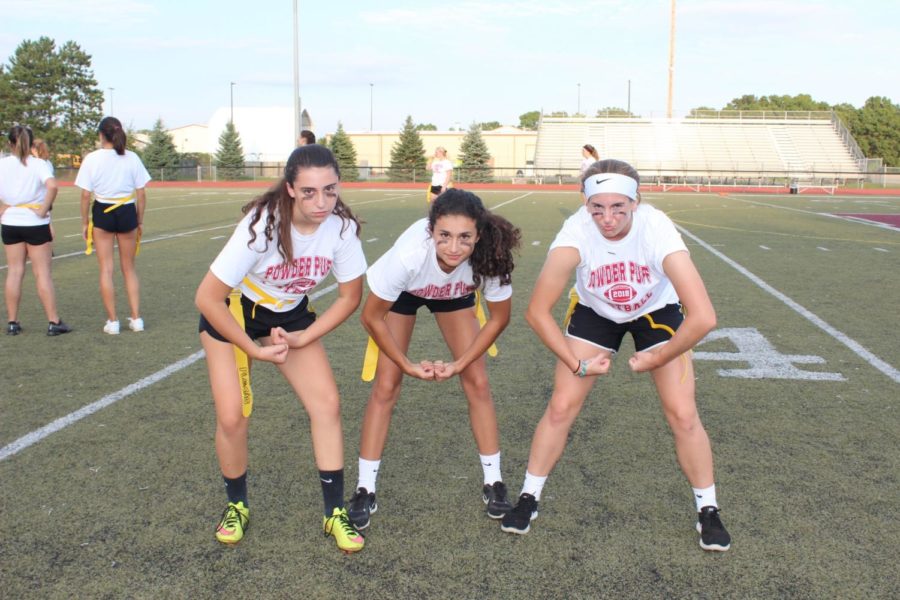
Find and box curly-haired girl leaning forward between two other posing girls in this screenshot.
[349,189,521,529]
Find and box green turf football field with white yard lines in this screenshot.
[0,188,900,598]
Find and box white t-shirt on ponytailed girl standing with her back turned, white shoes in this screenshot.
[75,148,151,204]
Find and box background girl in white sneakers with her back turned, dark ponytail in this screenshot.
[75,117,150,335]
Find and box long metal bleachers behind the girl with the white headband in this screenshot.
[534,111,865,188]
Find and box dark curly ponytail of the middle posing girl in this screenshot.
[428,188,522,287]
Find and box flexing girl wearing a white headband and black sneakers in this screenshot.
[501,160,731,551]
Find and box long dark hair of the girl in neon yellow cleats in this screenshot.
[241,144,362,263]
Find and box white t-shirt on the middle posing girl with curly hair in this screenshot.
[366,219,512,302]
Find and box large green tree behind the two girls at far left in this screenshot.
[0,37,103,154]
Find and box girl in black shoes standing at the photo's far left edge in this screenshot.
[0,125,71,336]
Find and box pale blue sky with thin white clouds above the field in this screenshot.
[0,0,900,135]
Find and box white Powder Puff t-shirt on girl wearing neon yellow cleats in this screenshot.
[209,212,366,312]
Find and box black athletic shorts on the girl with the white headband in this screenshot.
[566,303,684,354]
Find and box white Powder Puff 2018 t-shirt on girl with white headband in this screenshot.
[550,204,687,323]
